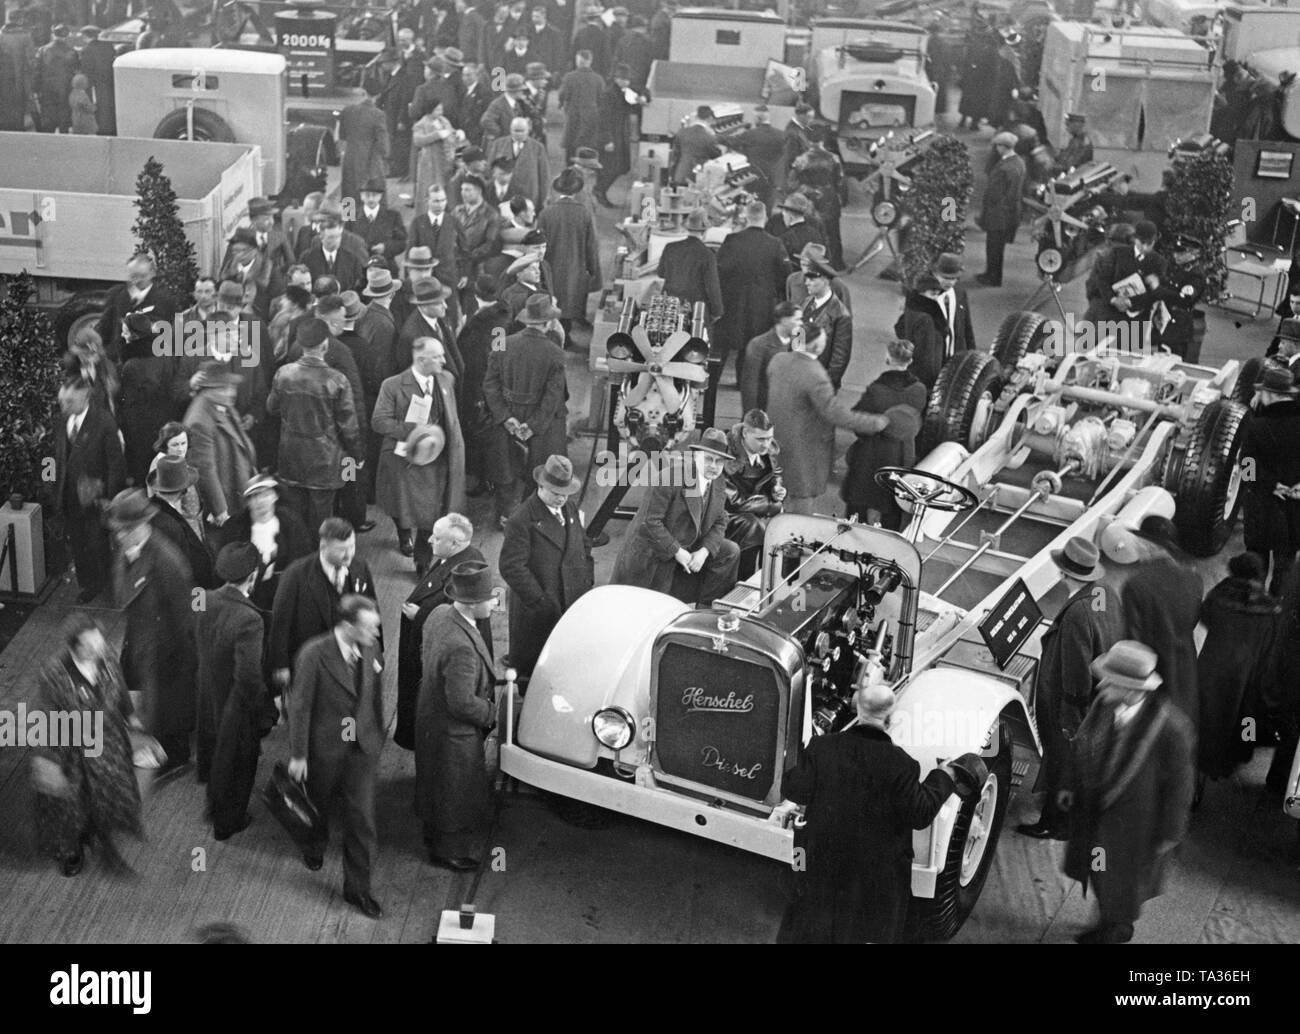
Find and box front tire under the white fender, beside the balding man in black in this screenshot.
[907,722,1015,940]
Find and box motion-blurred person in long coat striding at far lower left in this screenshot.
[31,614,142,877]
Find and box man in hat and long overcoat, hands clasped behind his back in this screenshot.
[484,294,568,527]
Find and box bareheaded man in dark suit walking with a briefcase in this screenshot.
[289,593,386,920]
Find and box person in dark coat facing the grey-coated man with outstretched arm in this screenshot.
[840,341,926,532]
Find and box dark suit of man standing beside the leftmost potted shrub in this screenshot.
[51,404,126,593]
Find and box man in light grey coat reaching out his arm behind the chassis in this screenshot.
[767,324,889,514]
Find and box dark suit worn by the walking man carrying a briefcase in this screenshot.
[289,626,385,897]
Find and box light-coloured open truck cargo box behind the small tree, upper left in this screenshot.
[0,133,261,281]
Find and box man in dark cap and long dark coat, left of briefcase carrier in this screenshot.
[195,542,274,840]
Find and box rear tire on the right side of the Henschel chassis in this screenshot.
[1170,398,1248,557]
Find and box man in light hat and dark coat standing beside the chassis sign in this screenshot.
[1017,536,1123,840]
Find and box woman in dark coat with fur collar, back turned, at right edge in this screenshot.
[1196,553,1282,779]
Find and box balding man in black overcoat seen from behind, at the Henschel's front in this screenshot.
[771,682,988,944]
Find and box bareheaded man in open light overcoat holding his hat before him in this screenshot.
[371,337,465,574]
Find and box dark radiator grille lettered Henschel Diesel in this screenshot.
[655,643,783,800]
